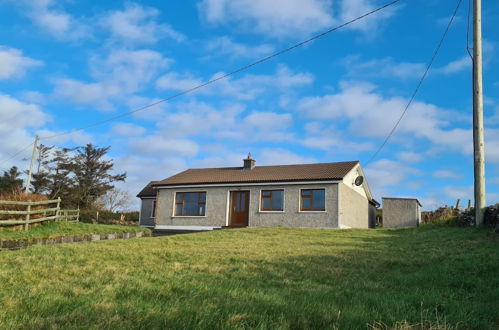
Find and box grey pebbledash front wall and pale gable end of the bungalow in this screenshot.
[156,183,369,228]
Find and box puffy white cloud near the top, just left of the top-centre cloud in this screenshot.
[101,3,185,44]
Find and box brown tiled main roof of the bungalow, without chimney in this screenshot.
[152,161,359,187]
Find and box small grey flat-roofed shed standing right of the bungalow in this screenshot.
[382,197,421,228]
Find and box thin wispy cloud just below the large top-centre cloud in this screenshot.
[206,36,274,59]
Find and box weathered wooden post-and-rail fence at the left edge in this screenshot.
[0,198,80,230]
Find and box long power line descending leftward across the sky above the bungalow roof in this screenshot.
[40,0,401,140]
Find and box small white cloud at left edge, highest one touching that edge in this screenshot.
[0,46,43,80]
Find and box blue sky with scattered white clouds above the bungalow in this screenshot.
[0,0,499,209]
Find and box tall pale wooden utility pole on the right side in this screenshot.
[473,0,485,227]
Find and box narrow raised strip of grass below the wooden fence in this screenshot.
[0,222,148,240]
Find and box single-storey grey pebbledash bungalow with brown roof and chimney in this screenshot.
[137,155,379,230]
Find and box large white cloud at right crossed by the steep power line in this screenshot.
[297,82,472,154]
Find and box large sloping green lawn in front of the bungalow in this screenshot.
[0,227,499,329]
